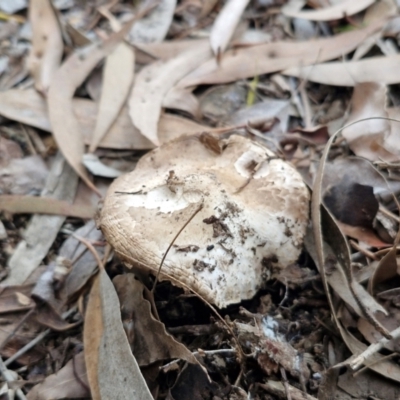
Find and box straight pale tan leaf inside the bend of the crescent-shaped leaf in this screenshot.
[89,43,135,153]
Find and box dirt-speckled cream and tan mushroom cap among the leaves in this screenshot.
[98,134,309,308]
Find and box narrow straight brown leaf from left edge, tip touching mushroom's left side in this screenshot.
[0,195,96,219]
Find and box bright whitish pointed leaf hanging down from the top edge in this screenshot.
[210,0,249,57]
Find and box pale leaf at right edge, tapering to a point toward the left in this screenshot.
[282,54,400,86]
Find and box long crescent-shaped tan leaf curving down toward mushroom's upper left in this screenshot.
[47,19,134,192]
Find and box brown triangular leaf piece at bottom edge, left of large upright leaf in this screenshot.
[27,352,90,400]
